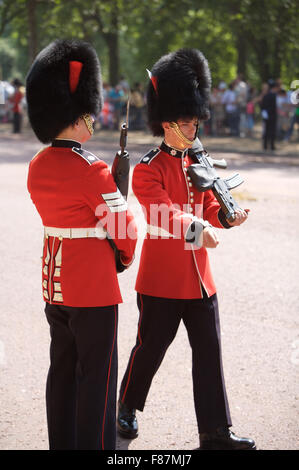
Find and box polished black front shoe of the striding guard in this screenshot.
[199,428,256,450]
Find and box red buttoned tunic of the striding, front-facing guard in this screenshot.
[132,143,229,299]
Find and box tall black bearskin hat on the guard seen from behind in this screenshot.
[26,40,102,143]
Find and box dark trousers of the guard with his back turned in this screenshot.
[45,303,118,450]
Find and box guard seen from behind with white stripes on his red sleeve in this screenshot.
[26,40,136,450]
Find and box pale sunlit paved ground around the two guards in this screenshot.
[0,126,299,450]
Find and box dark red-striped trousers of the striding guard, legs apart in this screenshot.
[120,294,231,432]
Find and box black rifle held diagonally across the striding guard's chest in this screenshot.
[187,138,244,222]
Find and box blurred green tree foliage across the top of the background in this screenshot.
[0,0,299,89]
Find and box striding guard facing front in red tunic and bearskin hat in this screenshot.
[117,49,255,449]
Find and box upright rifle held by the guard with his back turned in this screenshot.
[107,99,130,273]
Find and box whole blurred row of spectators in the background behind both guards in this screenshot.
[0,75,299,150]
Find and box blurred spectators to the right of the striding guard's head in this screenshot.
[204,75,299,147]
